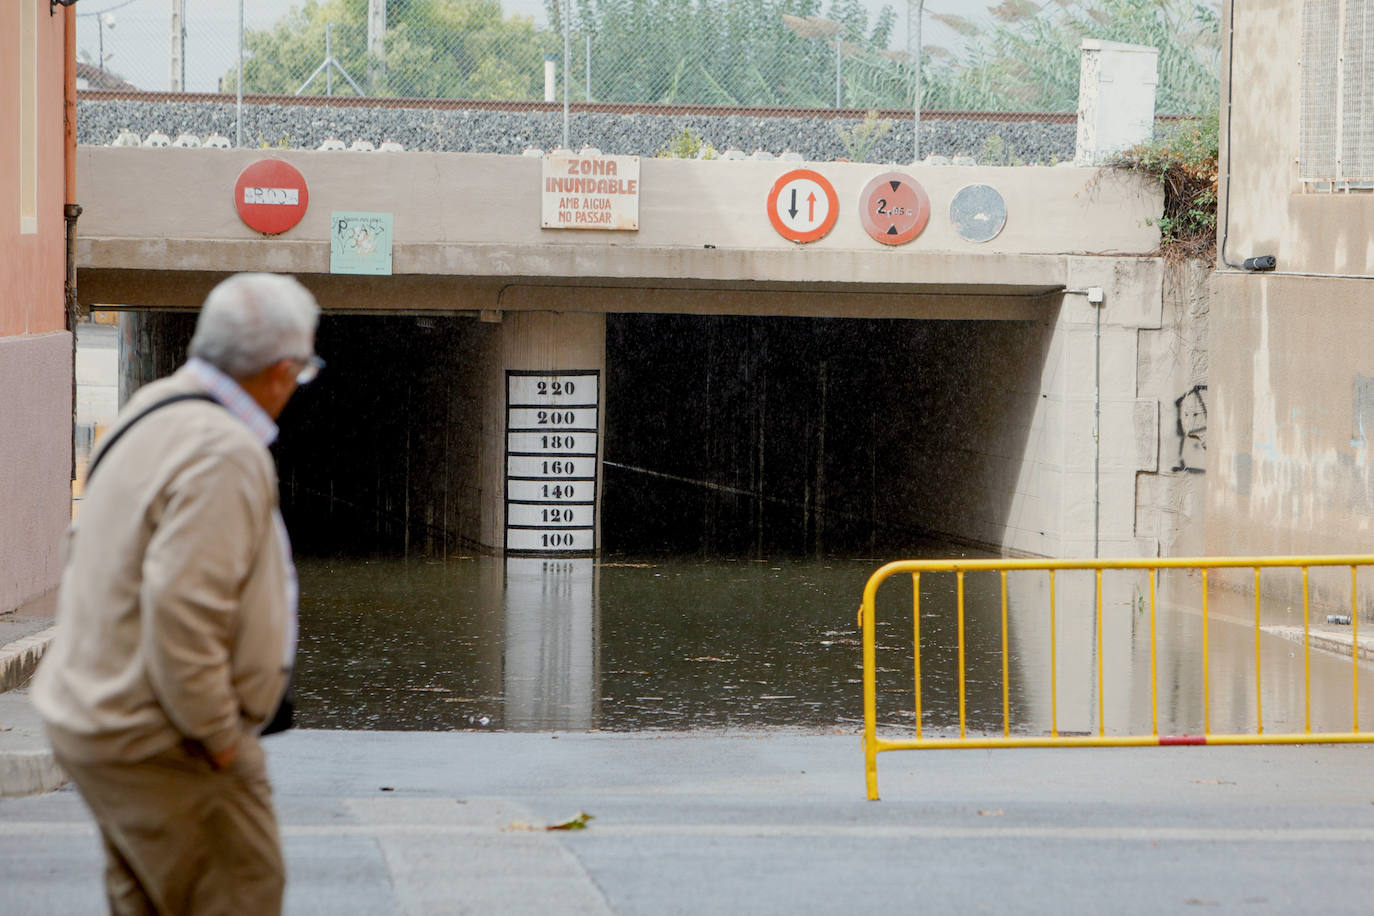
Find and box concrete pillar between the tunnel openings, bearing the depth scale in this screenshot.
[481,312,606,556]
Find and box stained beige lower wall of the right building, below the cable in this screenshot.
[1206,273,1374,601]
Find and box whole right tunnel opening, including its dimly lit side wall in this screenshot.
[602,314,1048,558]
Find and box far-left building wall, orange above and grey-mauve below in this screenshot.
[0,0,71,614]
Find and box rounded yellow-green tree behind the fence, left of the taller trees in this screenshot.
[221,0,558,99]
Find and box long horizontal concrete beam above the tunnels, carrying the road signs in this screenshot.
[78,147,1161,311]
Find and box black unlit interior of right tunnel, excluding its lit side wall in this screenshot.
[602,314,923,556]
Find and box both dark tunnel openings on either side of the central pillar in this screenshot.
[121,312,1052,558]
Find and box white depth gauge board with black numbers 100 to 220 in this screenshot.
[506,369,600,556]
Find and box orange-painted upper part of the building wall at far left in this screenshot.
[0,0,66,336]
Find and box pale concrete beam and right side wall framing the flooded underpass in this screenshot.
[78,148,1178,555]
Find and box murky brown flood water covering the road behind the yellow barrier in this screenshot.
[287,548,1374,735]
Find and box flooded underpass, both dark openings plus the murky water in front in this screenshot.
[109,316,1374,735]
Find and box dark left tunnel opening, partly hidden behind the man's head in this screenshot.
[120,312,492,558]
